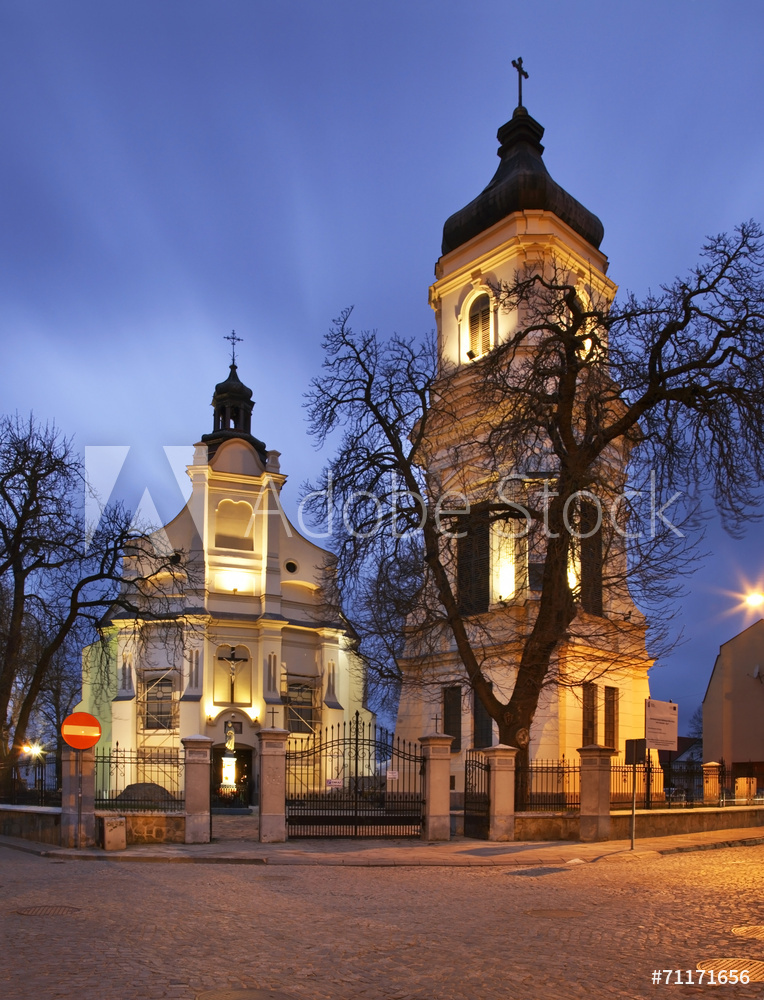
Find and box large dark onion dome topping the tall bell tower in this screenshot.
[442,106,605,254]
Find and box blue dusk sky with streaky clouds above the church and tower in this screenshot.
[0,0,764,732]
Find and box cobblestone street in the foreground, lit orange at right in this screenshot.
[0,846,764,1000]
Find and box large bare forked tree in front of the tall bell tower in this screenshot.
[305,223,764,760]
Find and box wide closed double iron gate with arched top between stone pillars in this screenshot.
[286,712,424,837]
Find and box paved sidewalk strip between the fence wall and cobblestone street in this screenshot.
[0,827,764,868]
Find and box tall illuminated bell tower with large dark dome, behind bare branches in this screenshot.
[397,94,652,791]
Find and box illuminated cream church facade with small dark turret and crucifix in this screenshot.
[80,362,371,799]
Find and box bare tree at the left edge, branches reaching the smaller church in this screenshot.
[0,416,183,759]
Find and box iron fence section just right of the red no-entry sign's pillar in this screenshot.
[95,746,185,812]
